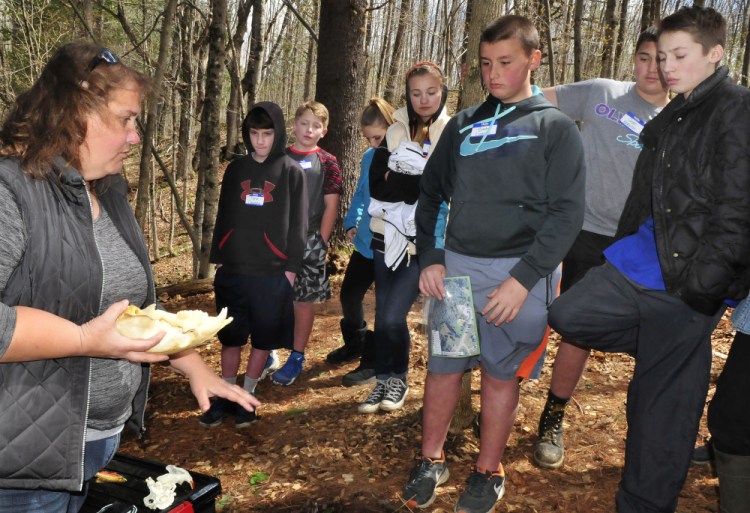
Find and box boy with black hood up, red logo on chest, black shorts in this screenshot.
[200,102,307,428]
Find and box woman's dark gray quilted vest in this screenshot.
[0,159,155,491]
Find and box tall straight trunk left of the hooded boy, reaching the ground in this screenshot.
[194,0,227,278]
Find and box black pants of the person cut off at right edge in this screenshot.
[708,331,750,456]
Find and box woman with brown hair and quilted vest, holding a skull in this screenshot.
[0,42,257,513]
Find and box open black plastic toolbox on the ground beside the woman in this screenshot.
[81,453,221,513]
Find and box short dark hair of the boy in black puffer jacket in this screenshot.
[658,5,727,55]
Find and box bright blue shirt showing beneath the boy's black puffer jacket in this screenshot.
[604,216,667,290]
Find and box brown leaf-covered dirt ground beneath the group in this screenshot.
[114,253,732,513]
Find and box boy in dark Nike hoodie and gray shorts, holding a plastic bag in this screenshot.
[404,16,585,513]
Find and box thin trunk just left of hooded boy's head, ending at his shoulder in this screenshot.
[223,0,253,160]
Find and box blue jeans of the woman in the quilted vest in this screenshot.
[0,433,120,513]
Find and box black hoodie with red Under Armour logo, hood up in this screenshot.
[210,102,307,276]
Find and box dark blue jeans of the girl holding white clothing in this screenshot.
[374,251,419,379]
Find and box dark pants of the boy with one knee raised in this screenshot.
[549,264,722,513]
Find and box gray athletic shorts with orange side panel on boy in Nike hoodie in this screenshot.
[427,251,561,380]
